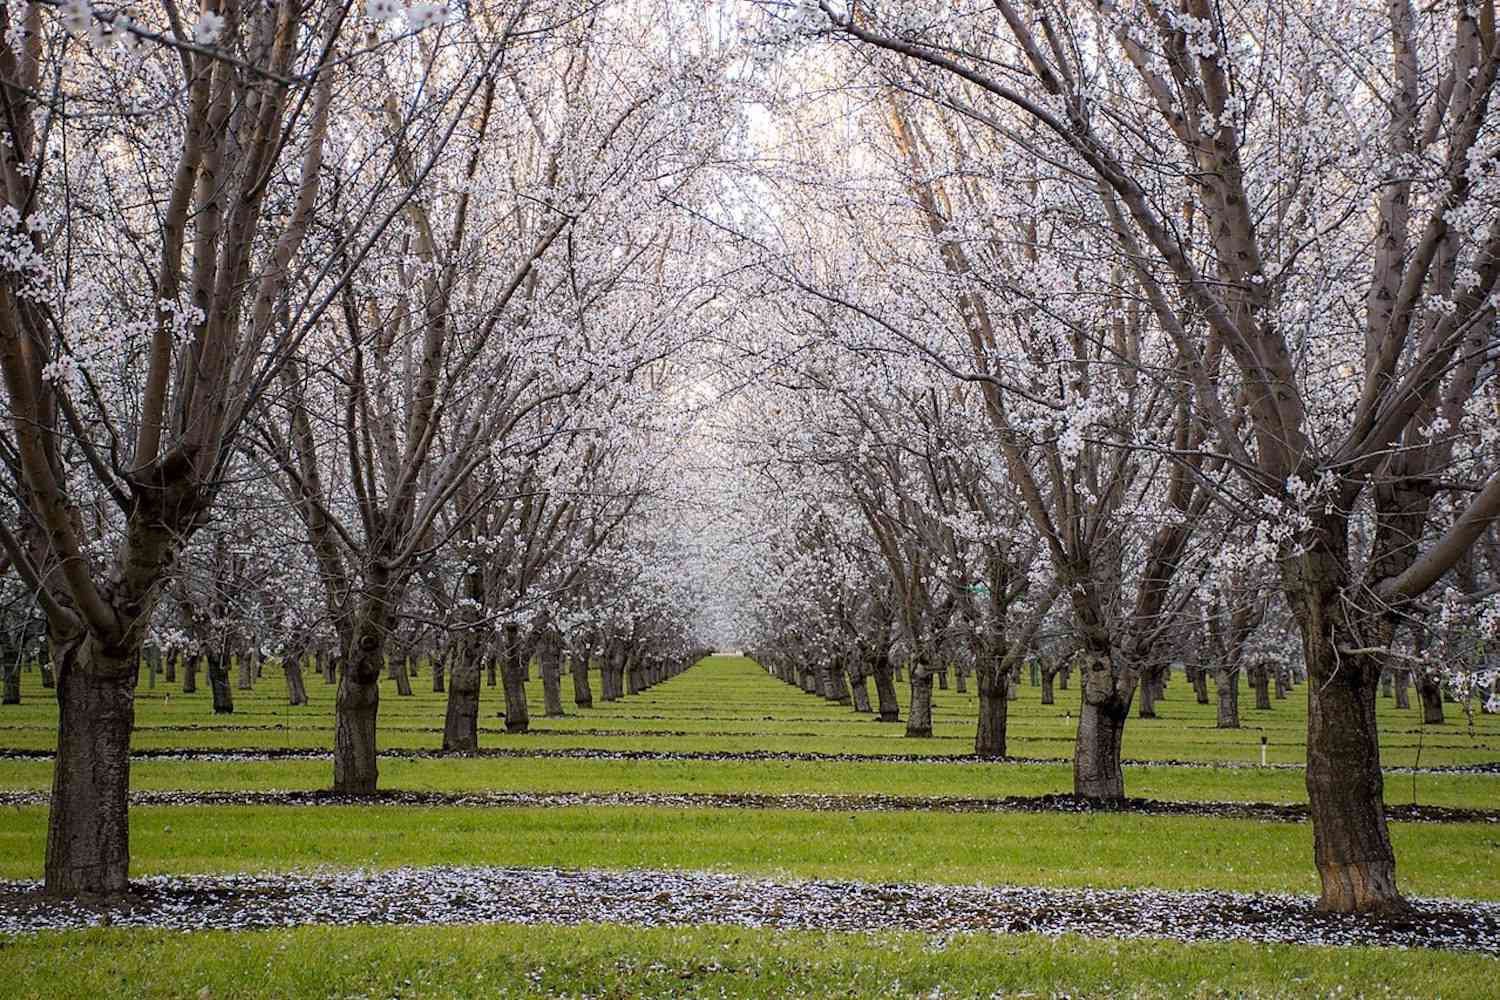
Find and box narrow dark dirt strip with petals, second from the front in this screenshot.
[0,790,1500,825]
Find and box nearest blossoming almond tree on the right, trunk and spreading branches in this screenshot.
[821,0,1500,912]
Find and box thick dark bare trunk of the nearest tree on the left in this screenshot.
[45,640,140,897]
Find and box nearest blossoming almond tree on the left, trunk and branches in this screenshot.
[0,0,360,895]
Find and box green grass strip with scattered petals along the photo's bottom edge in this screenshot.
[0,925,1500,1000]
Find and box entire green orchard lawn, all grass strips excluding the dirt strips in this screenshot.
[0,657,1500,997]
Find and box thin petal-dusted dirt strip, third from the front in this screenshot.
[0,747,1500,775]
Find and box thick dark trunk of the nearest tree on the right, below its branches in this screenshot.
[1283,530,1406,913]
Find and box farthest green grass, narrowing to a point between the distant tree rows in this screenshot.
[0,657,1500,766]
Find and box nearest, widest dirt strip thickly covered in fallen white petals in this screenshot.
[0,868,1500,955]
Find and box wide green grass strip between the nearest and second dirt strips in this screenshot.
[0,807,1500,900]
